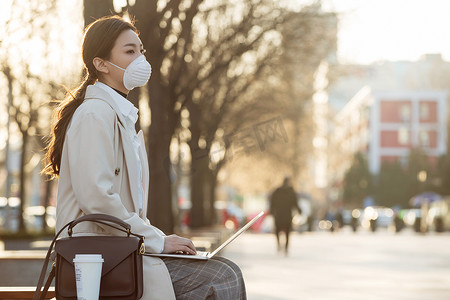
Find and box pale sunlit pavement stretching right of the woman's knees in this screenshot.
[224,231,450,300]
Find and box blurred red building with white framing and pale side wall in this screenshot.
[332,87,447,178]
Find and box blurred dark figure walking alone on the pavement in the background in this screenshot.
[270,177,302,254]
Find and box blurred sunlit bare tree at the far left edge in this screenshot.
[0,1,63,231]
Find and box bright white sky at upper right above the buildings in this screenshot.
[323,0,450,63]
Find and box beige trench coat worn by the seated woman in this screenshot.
[56,85,175,300]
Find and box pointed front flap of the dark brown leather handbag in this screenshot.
[55,236,140,276]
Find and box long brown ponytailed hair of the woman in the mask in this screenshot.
[42,16,137,177]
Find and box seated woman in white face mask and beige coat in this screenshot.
[44,16,246,300]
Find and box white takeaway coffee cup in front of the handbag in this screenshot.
[73,254,104,300]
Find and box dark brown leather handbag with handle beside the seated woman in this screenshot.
[33,214,145,300]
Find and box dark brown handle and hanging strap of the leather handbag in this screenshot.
[33,214,145,300]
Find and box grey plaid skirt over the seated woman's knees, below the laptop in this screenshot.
[163,257,247,300]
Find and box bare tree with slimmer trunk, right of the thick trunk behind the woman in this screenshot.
[186,1,289,227]
